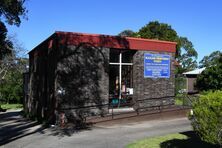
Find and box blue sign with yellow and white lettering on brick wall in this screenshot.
[144,53,170,78]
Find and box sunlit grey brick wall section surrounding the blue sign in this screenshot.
[133,51,175,109]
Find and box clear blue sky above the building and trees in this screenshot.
[7,0,222,61]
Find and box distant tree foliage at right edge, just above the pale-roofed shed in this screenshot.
[199,50,222,68]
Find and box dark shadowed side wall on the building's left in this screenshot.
[24,43,56,122]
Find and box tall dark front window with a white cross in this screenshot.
[109,49,136,102]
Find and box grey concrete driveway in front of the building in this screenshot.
[0,109,191,148]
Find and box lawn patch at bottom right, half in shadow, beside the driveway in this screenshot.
[126,131,218,148]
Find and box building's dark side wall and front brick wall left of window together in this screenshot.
[27,42,109,123]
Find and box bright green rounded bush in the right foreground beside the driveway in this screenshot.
[191,91,222,144]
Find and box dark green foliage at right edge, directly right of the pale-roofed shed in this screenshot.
[196,54,222,91]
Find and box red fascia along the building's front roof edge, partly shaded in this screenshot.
[56,32,176,53]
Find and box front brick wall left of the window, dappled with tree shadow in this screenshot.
[55,44,109,122]
